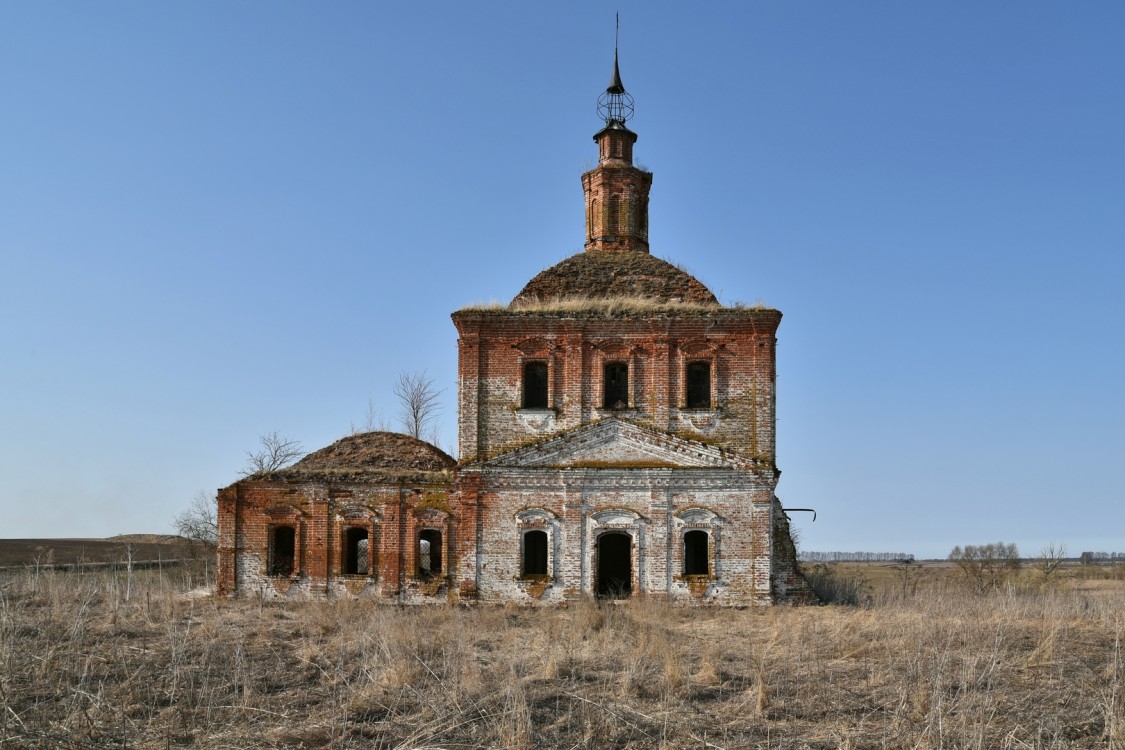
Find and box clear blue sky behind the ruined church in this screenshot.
[0,1,1125,557]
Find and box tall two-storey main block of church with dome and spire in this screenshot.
[452,54,812,605]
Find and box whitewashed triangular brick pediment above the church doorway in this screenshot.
[487,417,741,469]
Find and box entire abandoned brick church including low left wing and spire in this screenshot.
[218,49,813,605]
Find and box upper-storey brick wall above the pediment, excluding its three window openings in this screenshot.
[453,309,781,466]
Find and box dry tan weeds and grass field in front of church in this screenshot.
[0,573,1125,749]
